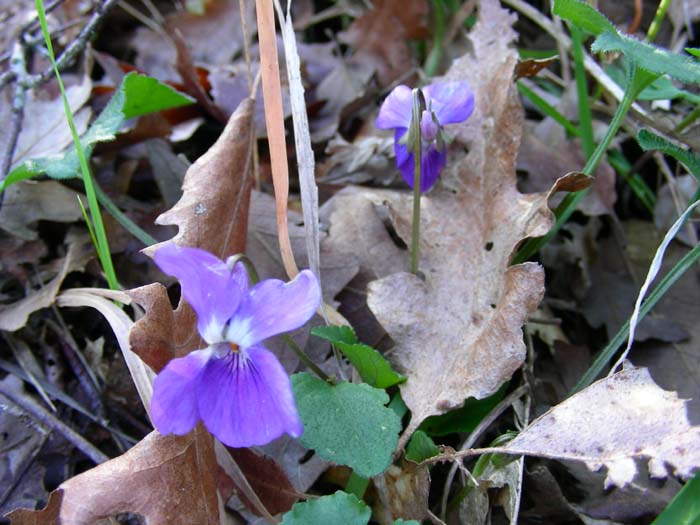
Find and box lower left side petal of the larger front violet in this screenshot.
[151,348,212,436]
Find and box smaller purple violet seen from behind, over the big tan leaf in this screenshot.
[376,82,474,191]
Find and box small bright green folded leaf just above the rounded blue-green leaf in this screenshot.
[311,326,406,388]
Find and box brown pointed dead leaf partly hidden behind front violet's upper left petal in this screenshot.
[129,99,253,372]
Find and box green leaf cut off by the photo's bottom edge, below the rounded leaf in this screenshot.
[282,490,372,525]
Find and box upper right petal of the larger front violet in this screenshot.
[226,270,321,347]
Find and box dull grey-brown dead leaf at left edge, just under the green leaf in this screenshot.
[0,180,82,241]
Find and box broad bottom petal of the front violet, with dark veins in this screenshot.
[196,347,304,447]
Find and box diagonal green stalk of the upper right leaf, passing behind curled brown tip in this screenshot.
[512,68,646,264]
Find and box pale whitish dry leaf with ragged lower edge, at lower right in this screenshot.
[505,368,700,487]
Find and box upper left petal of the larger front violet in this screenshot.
[153,243,248,344]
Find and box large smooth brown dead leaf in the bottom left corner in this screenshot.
[8,427,219,525]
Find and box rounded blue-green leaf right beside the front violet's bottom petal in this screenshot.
[292,373,401,477]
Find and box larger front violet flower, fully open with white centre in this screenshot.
[151,243,321,447]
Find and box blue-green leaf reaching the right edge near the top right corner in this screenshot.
[591,33,700,84]
